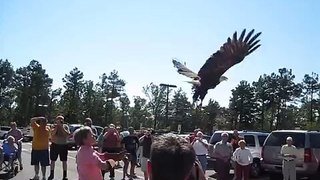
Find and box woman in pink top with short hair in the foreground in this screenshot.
[74,127,115,180]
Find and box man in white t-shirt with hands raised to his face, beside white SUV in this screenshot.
[191,131,208,173]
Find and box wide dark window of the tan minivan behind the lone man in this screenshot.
[265,132,305,148]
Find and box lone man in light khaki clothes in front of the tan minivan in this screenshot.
[280,137,297,180]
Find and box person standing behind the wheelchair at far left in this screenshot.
[7,122,23,170]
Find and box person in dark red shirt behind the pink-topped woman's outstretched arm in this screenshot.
[102,124,122,179]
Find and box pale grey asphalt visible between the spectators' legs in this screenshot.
[6,143,267,180]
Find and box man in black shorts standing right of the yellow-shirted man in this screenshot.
[48,116,70,180]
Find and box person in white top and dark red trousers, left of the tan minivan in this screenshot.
[233,140,253,180]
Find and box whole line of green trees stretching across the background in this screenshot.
[0,59,320,134]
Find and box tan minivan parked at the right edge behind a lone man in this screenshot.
[261,130,320,180]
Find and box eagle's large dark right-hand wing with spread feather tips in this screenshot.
[198,29,261,81]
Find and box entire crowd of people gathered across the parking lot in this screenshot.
[0,115,296,180]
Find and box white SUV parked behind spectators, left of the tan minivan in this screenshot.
[208,131,269,177]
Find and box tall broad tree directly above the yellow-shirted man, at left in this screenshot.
[14,60,52,125]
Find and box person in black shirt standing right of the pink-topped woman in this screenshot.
[121,127,139,179]
